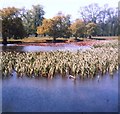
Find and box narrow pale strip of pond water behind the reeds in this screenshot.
[0,44,90,52]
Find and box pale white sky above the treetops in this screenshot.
[0,0,120,20]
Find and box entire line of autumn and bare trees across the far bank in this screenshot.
[0,3,119,43]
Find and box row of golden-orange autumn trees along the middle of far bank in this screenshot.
[37,14,96,40]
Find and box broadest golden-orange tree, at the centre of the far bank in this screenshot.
[37,14,70,41]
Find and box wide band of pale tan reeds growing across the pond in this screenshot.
[0,42,118,78]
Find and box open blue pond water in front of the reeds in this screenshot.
[2,72,118,112]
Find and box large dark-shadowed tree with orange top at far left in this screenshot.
[0,7,25,43]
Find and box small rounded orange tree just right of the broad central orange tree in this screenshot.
[70,19,86,39]
